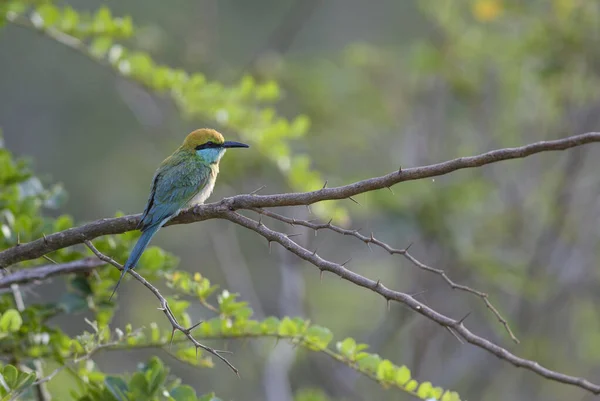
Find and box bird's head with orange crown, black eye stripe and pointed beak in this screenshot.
[181,128,249,164]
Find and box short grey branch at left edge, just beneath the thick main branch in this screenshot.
[0,258,106,289]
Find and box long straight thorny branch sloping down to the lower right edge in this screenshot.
[222,211,600,394]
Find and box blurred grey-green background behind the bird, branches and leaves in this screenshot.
[0,0,600,401]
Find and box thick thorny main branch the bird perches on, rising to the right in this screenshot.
[0,132,600,268]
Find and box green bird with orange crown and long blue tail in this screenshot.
[109,128,249,301]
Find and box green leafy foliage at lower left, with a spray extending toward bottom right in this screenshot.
[0,137,459,401]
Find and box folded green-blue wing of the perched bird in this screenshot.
[140,156,210,231]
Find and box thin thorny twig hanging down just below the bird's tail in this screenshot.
[84,240,240,377]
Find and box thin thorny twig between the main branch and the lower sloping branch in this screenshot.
[252,208,519,344]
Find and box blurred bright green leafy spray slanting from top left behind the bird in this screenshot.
[0,0,348,221]
